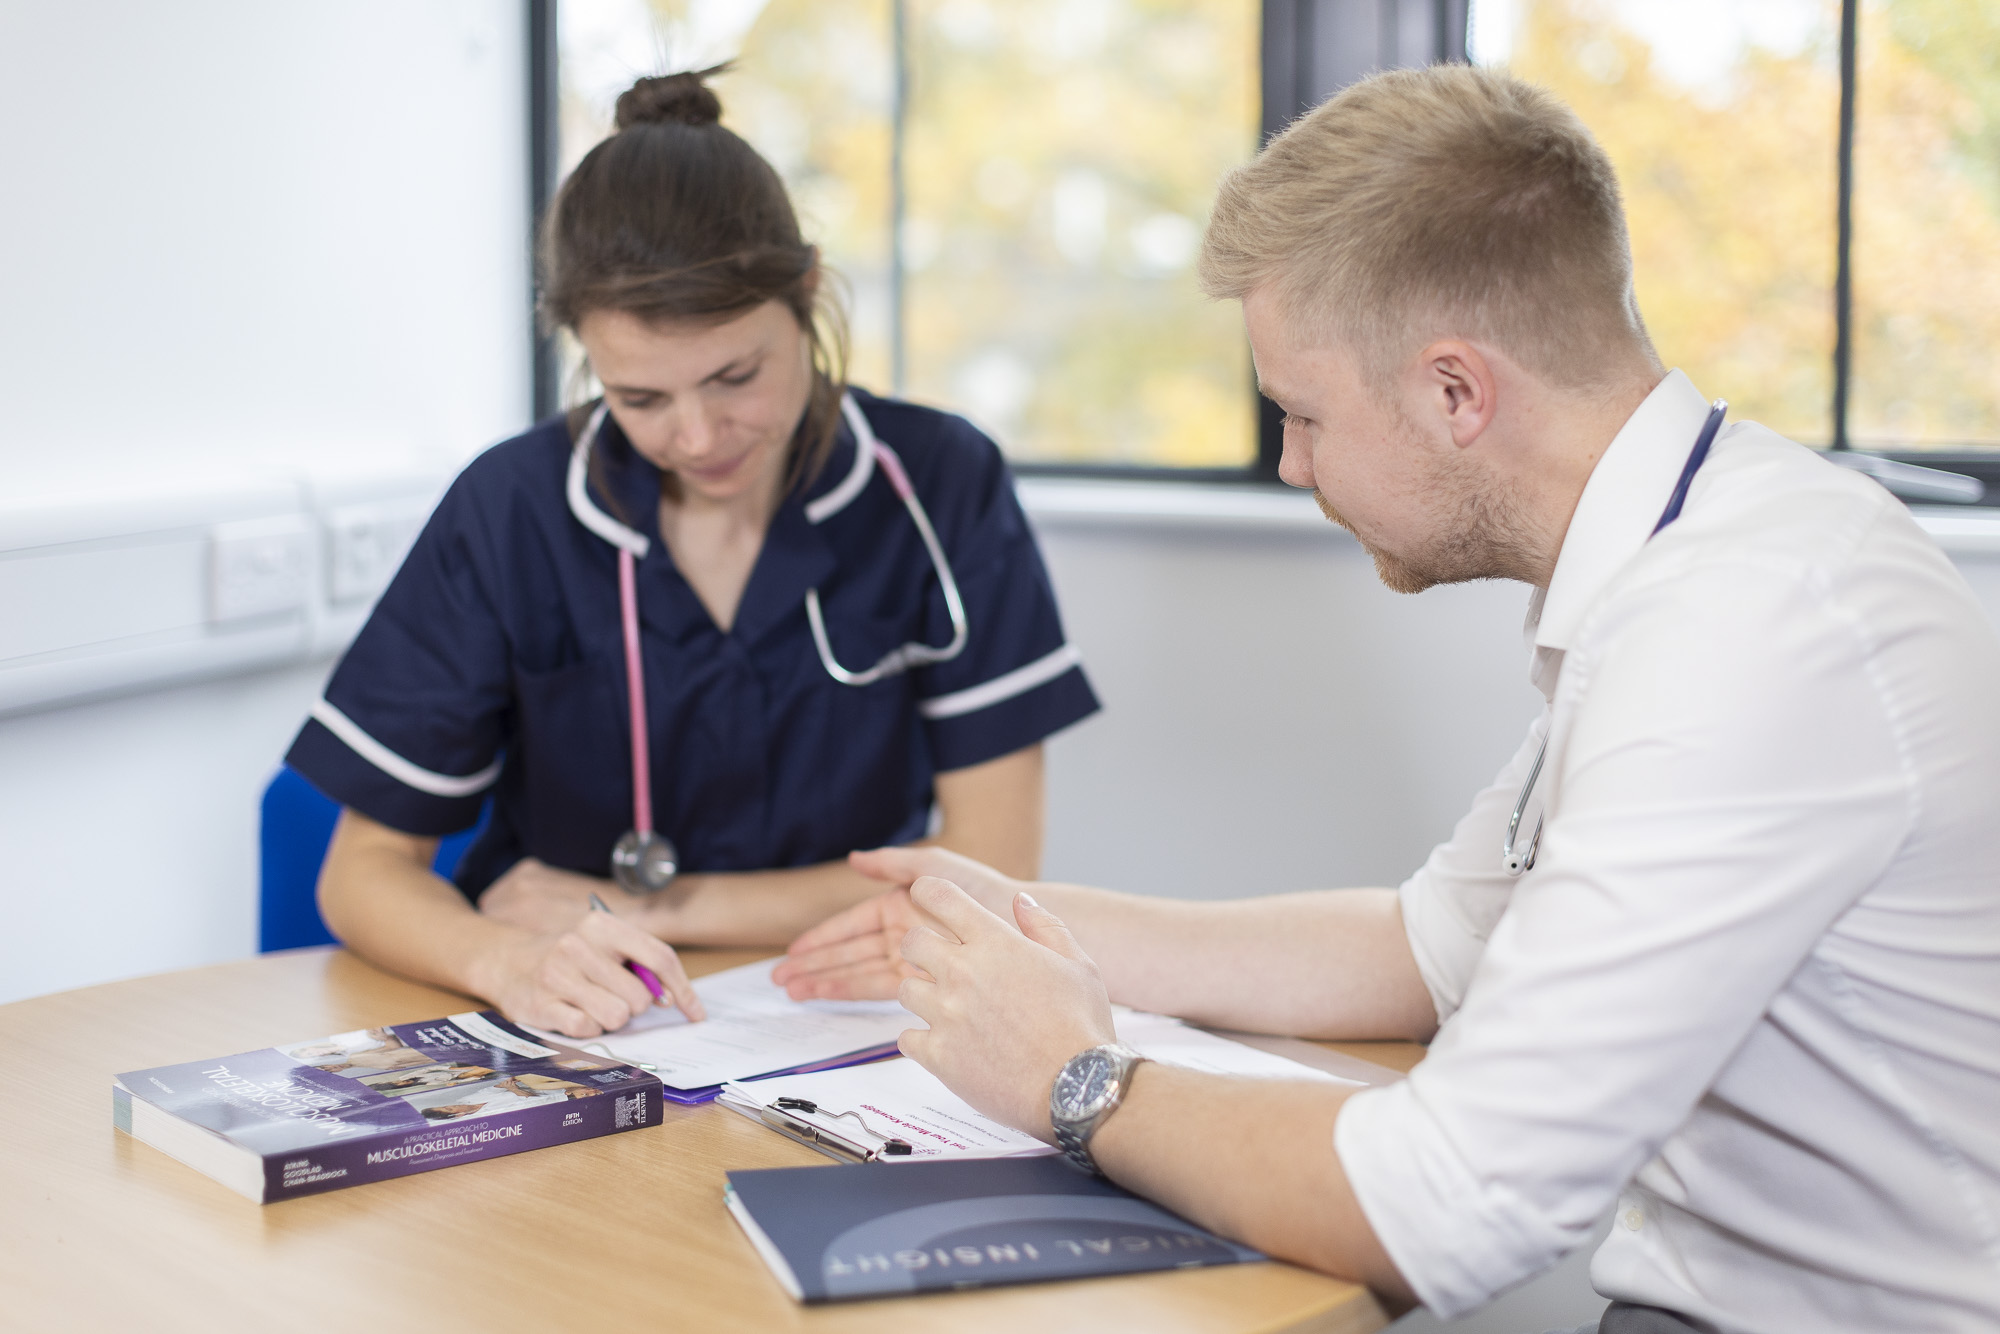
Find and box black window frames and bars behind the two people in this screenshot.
[526,0,2000,508]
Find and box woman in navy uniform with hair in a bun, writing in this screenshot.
[288,74,1096,1036]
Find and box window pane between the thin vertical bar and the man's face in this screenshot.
[904,0,1260,466]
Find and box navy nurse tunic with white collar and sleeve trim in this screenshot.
[286,390,1098,898]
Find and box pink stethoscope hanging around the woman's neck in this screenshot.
[576,394,968,894]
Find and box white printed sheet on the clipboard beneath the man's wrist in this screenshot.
[722,1006,1360,1162]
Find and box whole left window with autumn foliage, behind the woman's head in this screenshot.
[550,0,1260,470]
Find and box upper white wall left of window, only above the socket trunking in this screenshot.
[0,0,528,488]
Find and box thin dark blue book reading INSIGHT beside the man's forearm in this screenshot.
[724,1158,1264,1304]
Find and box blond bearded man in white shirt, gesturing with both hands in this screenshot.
[780,57,2000,1334]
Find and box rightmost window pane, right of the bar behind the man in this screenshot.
[1850,0,2000,448]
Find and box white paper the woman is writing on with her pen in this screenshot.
[532,958,924,1088]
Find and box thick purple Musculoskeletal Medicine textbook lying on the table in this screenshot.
[112,1010,662,1204]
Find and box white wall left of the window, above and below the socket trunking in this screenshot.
[0,0,530,1002]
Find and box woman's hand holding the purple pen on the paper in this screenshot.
[474,908,706,1038]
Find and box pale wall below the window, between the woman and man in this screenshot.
[1038,506,1540,898]
